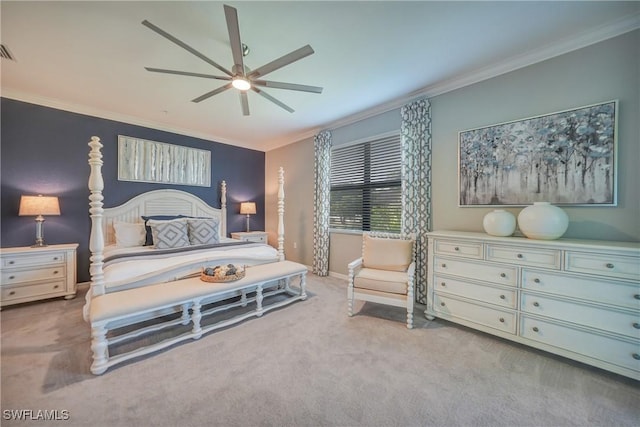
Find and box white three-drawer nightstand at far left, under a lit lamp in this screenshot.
[0,243,78,307]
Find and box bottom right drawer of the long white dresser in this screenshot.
[520,315,640,372]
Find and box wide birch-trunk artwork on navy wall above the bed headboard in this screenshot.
[118,135,211,187]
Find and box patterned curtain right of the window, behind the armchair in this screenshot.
[400,99,431,304]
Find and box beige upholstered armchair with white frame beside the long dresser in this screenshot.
[347,233,415,329]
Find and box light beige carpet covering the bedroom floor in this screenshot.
[0,275,640,427]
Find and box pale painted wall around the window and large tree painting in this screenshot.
[266,31,640,274]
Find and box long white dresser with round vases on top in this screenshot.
[425,231,640,380]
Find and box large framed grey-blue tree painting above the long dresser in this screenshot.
[458,100,618,206]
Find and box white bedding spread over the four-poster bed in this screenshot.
[103,239,278,292]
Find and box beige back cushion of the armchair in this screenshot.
[362,234,413,271]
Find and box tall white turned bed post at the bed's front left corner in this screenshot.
[82,136,104,321]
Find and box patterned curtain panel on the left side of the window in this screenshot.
[313,131,331,276]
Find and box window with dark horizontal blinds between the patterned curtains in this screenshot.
[329,135,402,233]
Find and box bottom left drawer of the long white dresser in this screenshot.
[433,293,516,335]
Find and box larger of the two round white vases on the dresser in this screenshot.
[518,202,569,240]
